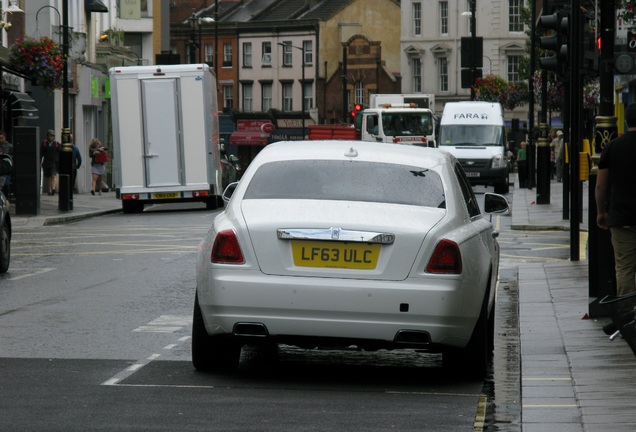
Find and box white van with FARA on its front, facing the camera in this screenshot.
[438,101,510,193]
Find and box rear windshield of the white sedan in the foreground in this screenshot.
[244,160,445,207]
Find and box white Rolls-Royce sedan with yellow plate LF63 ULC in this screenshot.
[192,141,508,377]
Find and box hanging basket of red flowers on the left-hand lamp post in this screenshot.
[10,36,64,89]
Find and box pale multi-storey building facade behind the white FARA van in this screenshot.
[401,0,528,122]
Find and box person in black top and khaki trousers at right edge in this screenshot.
[595,104,636,296]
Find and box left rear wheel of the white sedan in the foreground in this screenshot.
[192,296,241,371]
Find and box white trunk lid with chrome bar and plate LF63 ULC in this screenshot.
[241,200,445,280]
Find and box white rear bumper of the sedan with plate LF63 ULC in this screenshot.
[198,271,483,347]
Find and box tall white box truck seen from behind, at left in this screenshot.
[109,64,223,213]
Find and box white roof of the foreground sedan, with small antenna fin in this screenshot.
[254,140,453,168]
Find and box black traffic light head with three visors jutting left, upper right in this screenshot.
[539,11,570,76]
